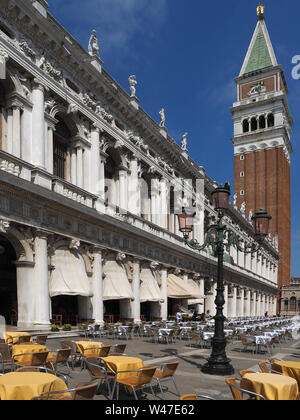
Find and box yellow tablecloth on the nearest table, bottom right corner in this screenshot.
[241,373,299,401]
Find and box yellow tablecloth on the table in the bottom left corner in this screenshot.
[0,372,67,401]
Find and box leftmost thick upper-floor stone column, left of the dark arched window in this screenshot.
[32,79,46,169]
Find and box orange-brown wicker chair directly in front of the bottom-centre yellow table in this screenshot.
[111,366,157,400]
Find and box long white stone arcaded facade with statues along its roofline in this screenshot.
[0,0,280,329]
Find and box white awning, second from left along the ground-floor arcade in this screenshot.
[103,260,134,300]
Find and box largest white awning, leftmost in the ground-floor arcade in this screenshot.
[49,247,93,297]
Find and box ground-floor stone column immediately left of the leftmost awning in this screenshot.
[34,231,50,328]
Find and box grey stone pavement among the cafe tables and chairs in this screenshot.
[47,334,300,401]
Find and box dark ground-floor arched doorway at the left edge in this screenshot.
[0,236,18,325]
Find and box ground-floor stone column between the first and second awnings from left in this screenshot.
[91,247,104,325]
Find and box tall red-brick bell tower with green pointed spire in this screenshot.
[231,5,293,287]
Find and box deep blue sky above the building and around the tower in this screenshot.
[48,0,300,277]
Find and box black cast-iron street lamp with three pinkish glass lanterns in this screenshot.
[178,183,272,376]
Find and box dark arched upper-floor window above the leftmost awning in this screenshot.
[53,119,71,179]
